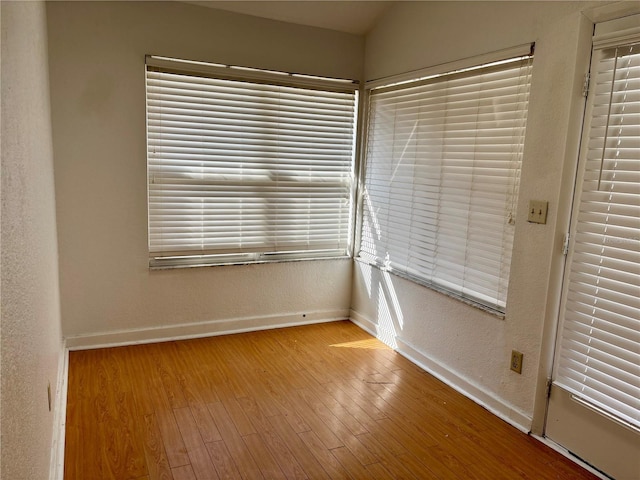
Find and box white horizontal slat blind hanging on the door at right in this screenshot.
[555,39,640,428]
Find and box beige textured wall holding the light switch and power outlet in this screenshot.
[352,2,592,433]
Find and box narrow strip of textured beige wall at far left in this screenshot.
[0,2,62,480]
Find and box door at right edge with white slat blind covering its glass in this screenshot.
[545,15,640,480]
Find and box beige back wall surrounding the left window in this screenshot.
[47,2,364,346]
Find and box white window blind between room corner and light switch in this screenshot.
[359,49,532,312]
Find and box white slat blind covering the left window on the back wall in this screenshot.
[146,59,357,266]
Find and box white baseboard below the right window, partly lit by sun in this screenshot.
[351,310,532,433]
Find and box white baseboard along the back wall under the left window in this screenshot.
[65,309,349,350]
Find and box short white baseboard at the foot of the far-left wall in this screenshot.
[49,341,69,480]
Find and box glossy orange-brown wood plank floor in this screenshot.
[65,321,596,480]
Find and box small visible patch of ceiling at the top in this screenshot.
[186,0,394,35]
